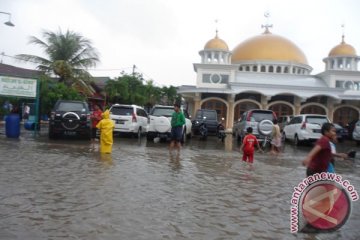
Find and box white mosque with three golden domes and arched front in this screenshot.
[178,24,360,129]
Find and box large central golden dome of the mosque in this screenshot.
[231,30,308,65]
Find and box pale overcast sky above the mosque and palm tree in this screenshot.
[0,0,360,86]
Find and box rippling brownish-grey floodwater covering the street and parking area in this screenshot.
[0,129,360,240]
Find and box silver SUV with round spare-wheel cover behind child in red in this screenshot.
[234,109,276,142]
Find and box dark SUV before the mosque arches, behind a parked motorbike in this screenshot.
[191,109,219,135]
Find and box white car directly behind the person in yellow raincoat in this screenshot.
[109,104,148,137]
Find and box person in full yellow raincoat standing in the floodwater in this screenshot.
[96,110,115,153]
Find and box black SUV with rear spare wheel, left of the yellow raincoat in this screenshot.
[49,100,91,139]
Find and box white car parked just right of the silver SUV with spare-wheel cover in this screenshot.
[283,114,330,145]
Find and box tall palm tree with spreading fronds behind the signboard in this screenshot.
[17,30,99,86]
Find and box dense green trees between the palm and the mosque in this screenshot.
[105,72,181,107]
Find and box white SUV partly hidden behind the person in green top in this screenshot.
[147,105,192,141]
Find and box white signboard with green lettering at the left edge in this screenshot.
[0,76,37,98]
